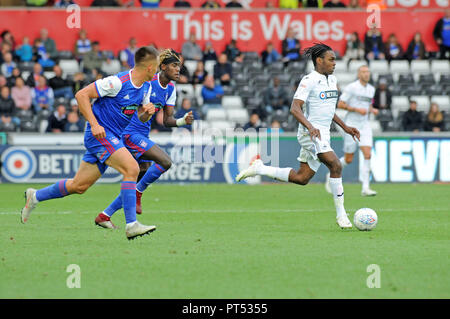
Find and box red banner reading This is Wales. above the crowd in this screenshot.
[0,9,443,54]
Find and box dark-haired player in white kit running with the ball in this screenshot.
[236,43,359,228]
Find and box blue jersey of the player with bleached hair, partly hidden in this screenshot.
[123,73,177,136]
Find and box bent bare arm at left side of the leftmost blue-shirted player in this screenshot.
[75,83,106,138]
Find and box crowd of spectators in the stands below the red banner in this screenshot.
[0,6,450,133]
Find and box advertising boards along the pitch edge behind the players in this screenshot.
[0,133,450,183]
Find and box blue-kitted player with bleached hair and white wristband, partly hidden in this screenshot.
[95,49,194,228]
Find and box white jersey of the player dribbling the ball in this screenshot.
[294,70,338,134]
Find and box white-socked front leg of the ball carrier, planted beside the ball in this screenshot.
[317,151,352,228]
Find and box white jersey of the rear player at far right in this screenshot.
[339,80,375,128]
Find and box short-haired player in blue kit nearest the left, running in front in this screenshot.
[21,47,159,239]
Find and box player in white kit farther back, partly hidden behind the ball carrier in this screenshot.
[325,65,378,196]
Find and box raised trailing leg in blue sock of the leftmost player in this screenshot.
[21,161,101,223]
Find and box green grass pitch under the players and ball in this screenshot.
[0,184,450,299]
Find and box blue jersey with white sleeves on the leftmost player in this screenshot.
[86,70,151,138]
